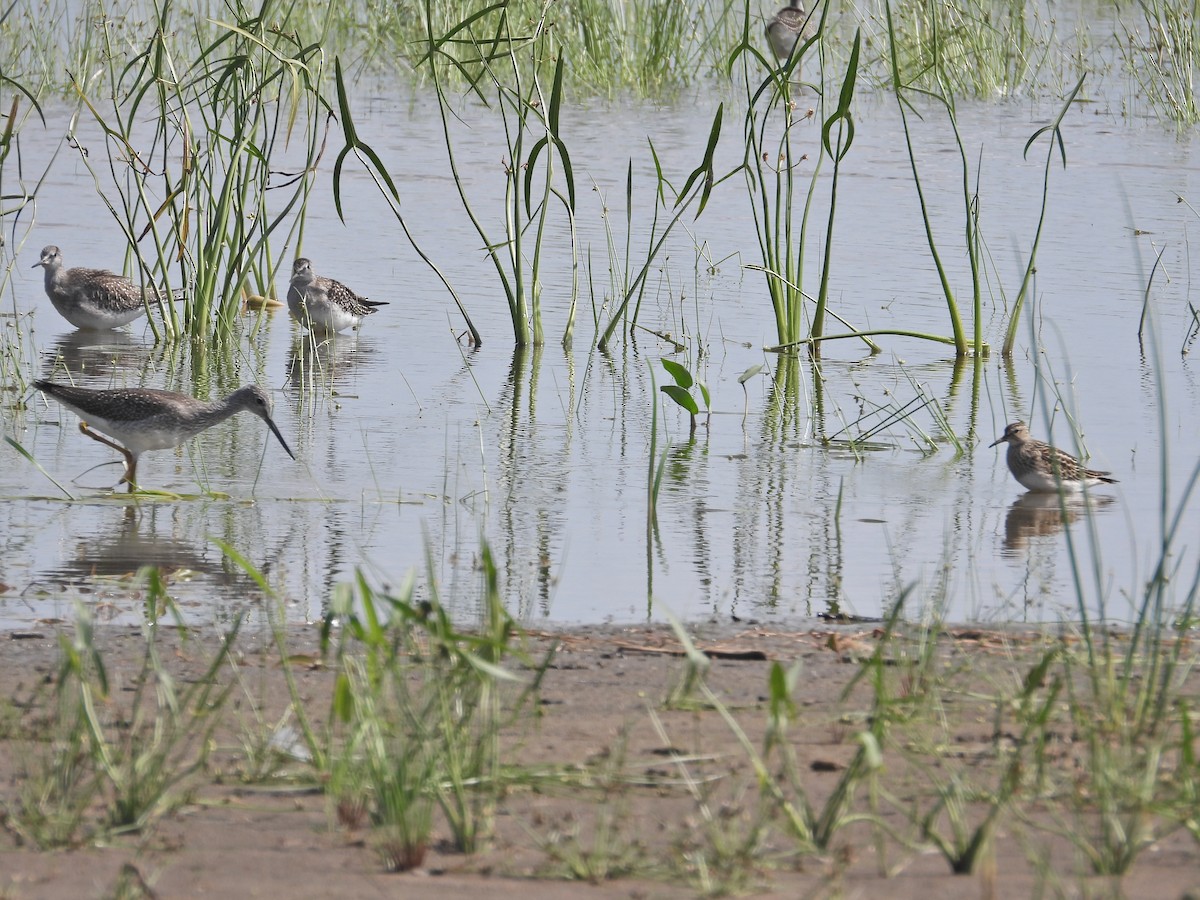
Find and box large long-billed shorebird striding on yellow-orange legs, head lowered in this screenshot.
[34,380,296,491]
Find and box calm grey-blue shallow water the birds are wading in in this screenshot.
[0,72,1200,626]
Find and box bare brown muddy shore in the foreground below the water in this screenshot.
[0,624,1200,900]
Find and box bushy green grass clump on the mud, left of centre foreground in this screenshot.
[323,546,550,869]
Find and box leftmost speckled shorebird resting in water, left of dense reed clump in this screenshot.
[32,244,182,329]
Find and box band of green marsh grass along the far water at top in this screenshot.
[0,0,1196,124]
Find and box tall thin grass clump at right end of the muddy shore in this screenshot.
[984,316,1200,876]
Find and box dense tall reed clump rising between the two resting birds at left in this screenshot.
[71,0,330,340]
